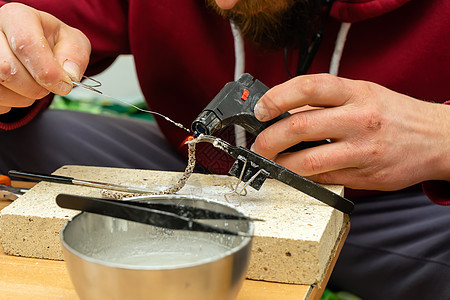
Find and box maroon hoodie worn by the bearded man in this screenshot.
[0,0,450,204]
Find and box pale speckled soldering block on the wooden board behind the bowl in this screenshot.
[0,166,348,284]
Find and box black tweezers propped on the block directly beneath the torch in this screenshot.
[197,134,355,214]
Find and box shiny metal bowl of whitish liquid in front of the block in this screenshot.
[61,196,254,300]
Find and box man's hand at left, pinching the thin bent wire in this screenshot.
[0,3,91,114]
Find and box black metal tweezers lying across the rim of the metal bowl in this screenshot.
[56,194,256,236]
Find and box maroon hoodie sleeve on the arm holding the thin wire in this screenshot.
[0,0,130,131]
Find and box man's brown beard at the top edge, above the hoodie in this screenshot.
[206,0,320,50]
